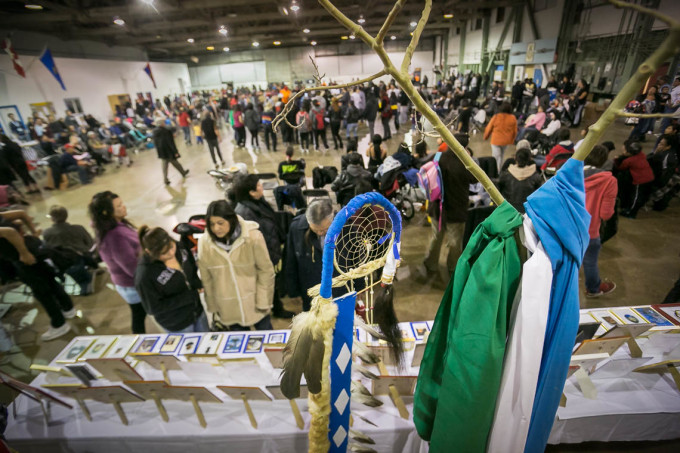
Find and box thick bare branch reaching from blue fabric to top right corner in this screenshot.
[574,0,680,160]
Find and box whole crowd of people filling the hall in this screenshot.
[0,69,680,340]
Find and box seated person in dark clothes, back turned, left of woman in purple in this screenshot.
[43,205,94,296]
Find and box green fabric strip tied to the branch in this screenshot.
[413,202,522,453]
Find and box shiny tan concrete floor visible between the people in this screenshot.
[0,116,680,452]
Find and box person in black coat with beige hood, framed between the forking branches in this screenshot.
[498,148,543,213]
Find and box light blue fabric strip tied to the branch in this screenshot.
[524,159,590,453]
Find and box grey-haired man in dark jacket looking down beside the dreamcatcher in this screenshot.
[284,198,334,311]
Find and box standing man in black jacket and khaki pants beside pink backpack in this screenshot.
[423,134,476,281]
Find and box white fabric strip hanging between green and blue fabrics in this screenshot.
[487,215,553,453]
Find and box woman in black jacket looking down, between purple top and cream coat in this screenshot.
[135,225,209,333]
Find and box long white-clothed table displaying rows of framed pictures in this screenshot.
[5,310,680,453]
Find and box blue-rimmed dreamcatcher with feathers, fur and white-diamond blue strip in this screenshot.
[281,192,403,453]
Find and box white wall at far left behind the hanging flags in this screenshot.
[0,54,191,120]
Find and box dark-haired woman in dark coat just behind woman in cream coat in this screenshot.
[233,175,293,319]
